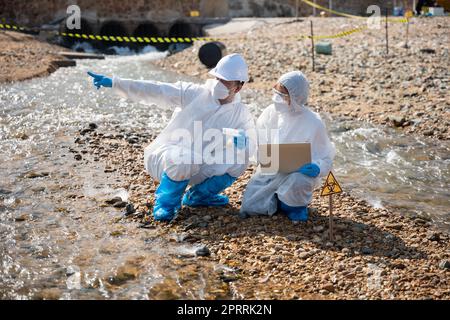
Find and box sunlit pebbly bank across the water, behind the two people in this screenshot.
[155,17,450,140]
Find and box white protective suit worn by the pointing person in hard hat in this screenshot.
[113,57,256,185]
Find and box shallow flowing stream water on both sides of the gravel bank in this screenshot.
[0,52,450,299]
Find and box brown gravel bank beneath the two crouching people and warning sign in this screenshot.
[68,125,450,299]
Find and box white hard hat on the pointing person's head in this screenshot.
[209,53,248,82]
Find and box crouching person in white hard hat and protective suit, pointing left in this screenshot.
[89,54,256,221]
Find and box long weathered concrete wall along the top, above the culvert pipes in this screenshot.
[0,0,410,37]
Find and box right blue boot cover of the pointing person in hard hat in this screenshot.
[183,173,236,207]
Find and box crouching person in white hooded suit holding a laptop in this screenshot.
[241,71,335,221]
